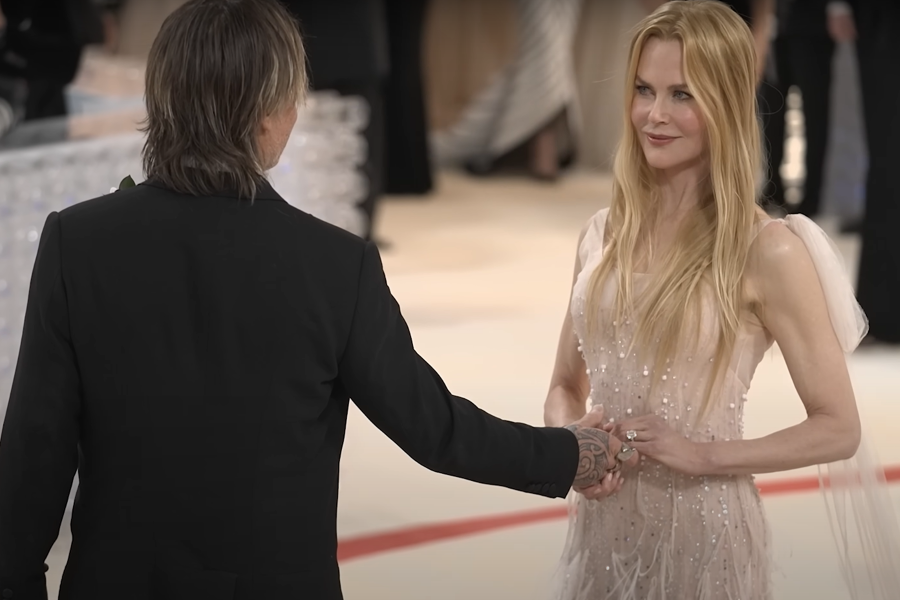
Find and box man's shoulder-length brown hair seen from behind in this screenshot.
[143,0,308,198]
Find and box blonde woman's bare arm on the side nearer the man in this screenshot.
[544,222,590,427]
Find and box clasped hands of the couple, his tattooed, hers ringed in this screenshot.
[569,405,706,500]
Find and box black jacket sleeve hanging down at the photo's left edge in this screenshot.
[0,213,81,600]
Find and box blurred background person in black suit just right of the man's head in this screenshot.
[282,0,390,240]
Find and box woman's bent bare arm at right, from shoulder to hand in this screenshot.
[614,223,860,475]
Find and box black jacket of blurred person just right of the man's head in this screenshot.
[281,0,384,89]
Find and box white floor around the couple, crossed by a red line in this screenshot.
[49,169,900,600]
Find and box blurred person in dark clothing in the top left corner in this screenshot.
[0,0,104,120]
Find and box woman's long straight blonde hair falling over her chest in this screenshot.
[585,0,763,415]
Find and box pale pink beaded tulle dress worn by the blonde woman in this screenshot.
[552,210,884,600]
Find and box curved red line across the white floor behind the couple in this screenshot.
[338,465,900,562]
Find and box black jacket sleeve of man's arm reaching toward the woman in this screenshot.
[340,244,578,497]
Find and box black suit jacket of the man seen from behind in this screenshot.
[0,183,578,600]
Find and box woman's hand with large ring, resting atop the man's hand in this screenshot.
[612,415,708,475]
